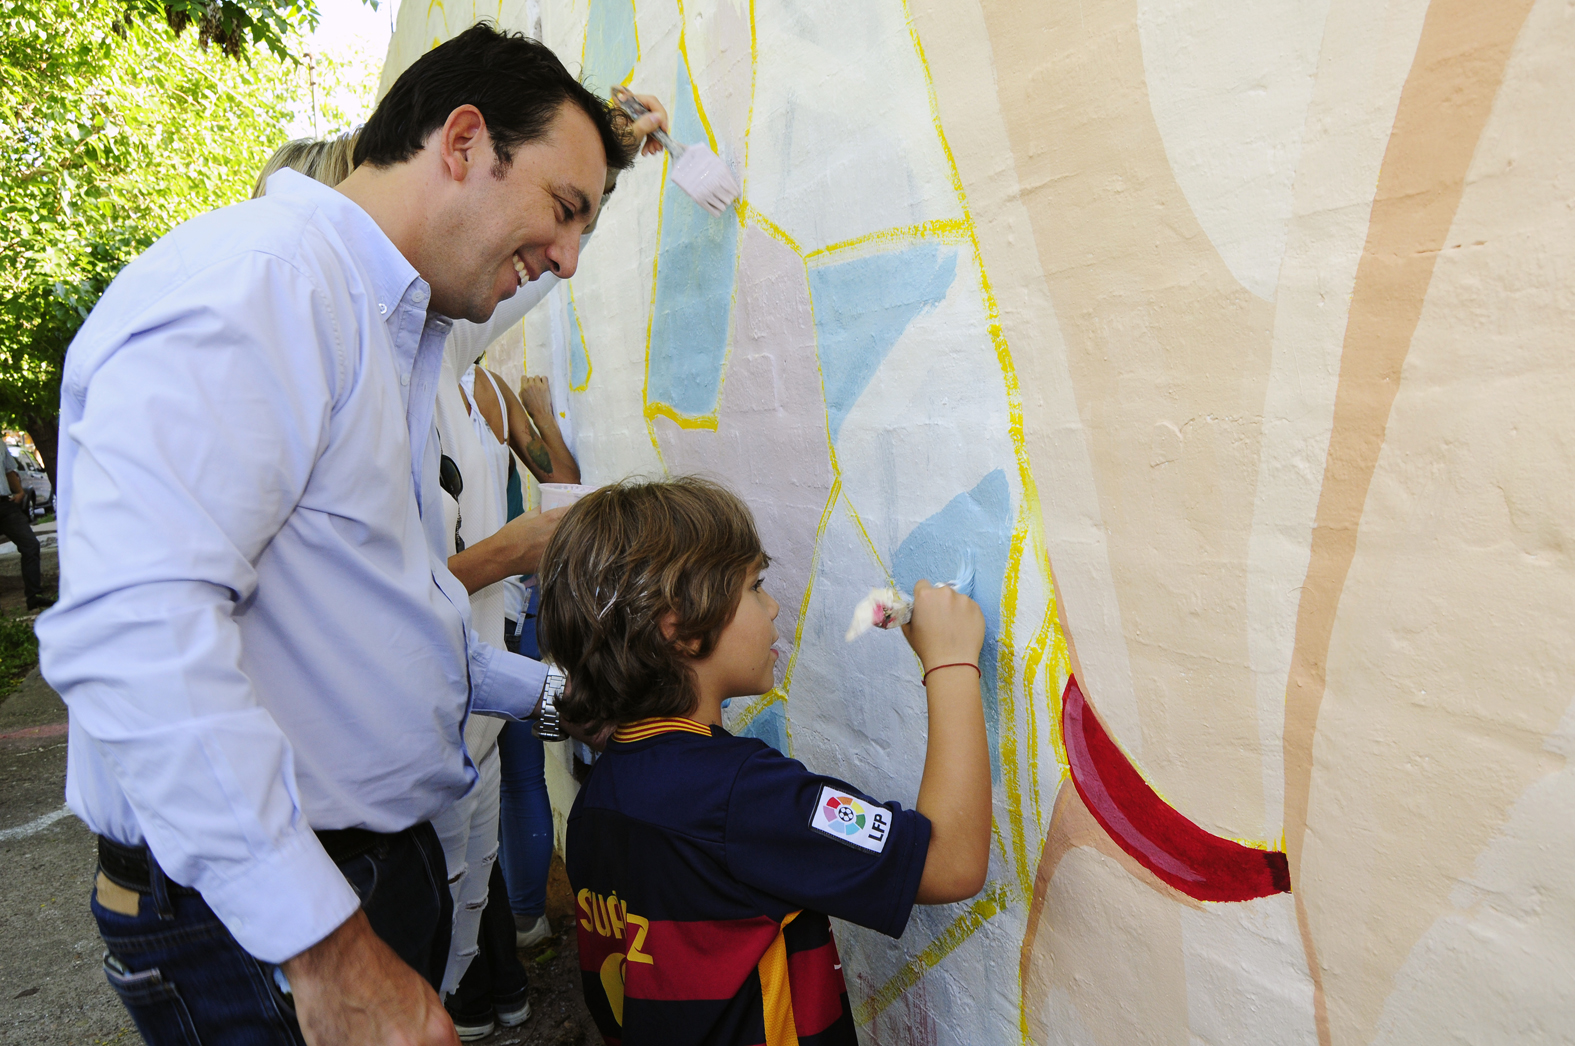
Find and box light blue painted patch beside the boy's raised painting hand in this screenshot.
[891,468,1011,781]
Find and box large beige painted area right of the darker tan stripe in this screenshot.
[1299,2,1575,1043]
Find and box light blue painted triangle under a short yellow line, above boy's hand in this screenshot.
[810,243,958,444]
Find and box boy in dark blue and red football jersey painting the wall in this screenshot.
[537,479,991,1046]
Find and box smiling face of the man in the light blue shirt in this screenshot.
[422,104,606,323]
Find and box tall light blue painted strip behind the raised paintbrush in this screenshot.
[646,61,740,416]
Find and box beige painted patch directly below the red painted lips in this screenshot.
[1022,848,1189,1046]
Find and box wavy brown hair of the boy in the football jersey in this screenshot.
[536,476,770,728]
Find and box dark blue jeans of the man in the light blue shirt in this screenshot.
[93,824,454,1046]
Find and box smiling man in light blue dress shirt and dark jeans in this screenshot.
[38,25,649,1043]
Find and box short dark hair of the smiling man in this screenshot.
[354,22,635,175]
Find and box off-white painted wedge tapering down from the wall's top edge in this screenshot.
[1137,0,1329,299]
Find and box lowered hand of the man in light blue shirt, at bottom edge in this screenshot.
[282,912,460,1046]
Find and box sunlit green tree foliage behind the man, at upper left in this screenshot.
[0,0,372,476]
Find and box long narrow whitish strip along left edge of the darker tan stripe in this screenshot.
[1247,0,1427,838]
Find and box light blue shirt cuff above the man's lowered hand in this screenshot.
[200,827,361,963]
